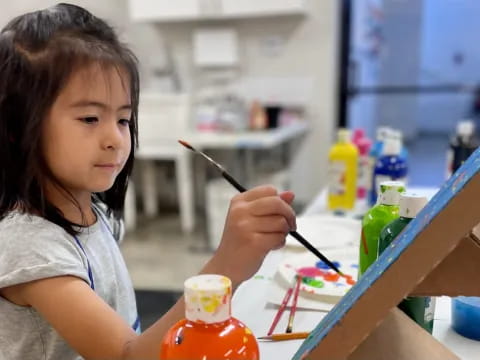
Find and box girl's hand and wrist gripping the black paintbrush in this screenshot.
[203,186,296,287]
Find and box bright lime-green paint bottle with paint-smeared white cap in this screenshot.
[358,181,405,277]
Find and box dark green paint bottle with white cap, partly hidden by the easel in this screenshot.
[378,193,435,334]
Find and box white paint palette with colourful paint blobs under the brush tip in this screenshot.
[276,247,358,302]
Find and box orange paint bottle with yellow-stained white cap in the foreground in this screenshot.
[160,275,260,360]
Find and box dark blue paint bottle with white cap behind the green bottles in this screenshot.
[372,137,408,202]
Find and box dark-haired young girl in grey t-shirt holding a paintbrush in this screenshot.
[0,4,295,360]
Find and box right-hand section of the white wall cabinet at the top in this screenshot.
[222,0,306,17]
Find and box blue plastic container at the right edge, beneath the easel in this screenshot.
[452,296,480,340]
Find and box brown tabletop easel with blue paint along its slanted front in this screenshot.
[294,161,480,360]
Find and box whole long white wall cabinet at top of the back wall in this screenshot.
[128,0,307,22]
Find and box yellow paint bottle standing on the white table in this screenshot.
[328,129,358,210]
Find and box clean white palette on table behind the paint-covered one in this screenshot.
[286,214,362,249]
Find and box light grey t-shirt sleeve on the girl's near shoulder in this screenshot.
[0,216,89,288]
